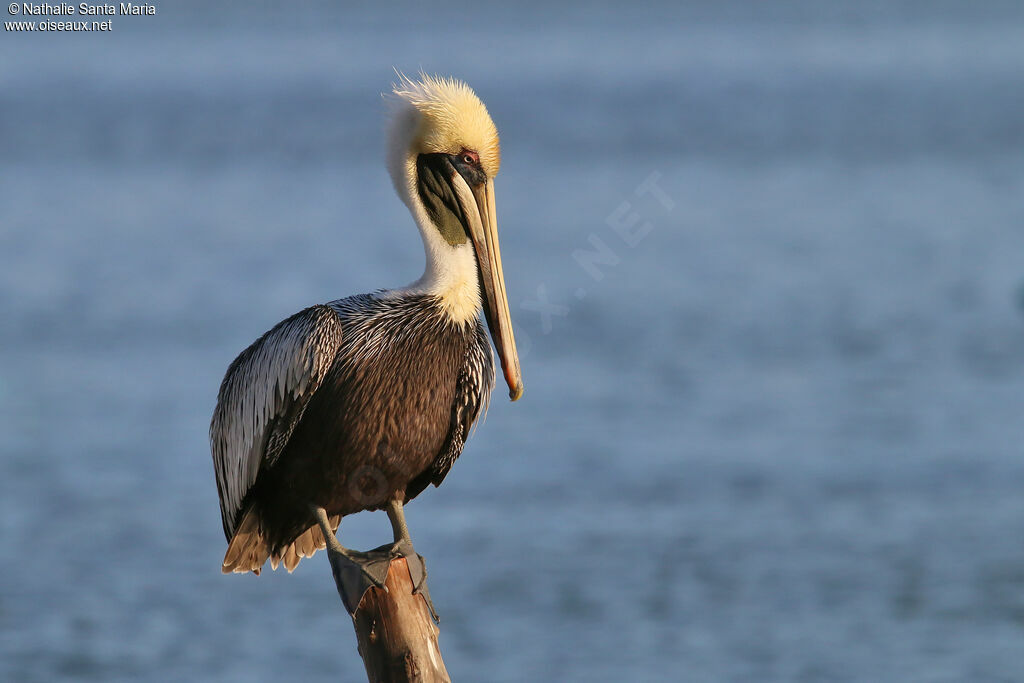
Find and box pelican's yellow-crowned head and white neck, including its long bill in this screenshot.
[388,74,523,400]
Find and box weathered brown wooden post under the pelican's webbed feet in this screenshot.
[344,557,452,683]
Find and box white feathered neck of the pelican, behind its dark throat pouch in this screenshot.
[388,102,482,324]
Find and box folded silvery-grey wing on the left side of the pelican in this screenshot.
[210,306,341,541]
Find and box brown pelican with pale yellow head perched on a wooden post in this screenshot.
[210,75,522,610]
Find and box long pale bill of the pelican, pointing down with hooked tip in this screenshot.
[452,172,523,400]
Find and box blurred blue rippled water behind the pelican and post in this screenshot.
[0,2,1024,681]
